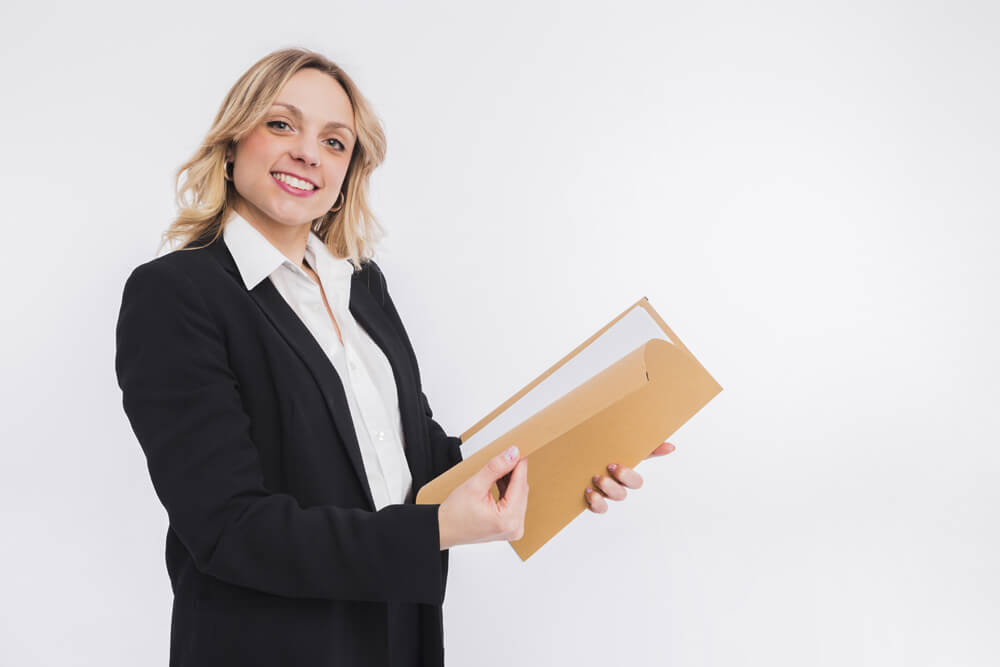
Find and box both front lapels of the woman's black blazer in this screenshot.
[208,236,430,511]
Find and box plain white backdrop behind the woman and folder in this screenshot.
[0,0,1000,667]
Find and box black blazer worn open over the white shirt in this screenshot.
[115,235,462,667]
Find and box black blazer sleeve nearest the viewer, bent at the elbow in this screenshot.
[115,260,445,605]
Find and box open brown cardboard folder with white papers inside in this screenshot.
[416,297,722,561]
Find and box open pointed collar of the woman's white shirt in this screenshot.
[222,210,354,290]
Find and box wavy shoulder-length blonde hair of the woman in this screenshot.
[160,48,385,270]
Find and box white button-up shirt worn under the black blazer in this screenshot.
[222,211,413,510]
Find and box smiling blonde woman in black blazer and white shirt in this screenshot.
[115,49,672,667]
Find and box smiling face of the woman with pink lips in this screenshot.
[230,69,356,237]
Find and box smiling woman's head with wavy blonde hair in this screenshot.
[161,49,385,270]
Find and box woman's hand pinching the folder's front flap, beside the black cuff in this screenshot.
[438,447,528,549]
